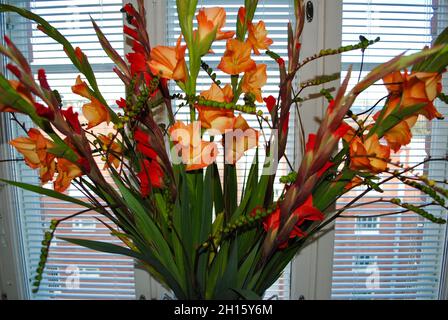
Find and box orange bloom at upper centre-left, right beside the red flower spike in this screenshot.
[148,36,187,82]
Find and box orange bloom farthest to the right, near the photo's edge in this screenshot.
[401,72,443,120]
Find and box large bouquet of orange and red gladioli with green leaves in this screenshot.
[0,0,448,299]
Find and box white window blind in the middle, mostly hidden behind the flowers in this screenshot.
[166,0,295,299]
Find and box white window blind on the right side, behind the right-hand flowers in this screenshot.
[331,0,448,299]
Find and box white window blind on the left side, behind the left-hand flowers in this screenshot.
[4,0,135,299]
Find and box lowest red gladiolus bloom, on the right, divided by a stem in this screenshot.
[263,196,324,249]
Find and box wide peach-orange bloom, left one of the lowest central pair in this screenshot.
[169,121,218,171]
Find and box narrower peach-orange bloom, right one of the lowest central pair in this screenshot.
[223,115,259,164]
